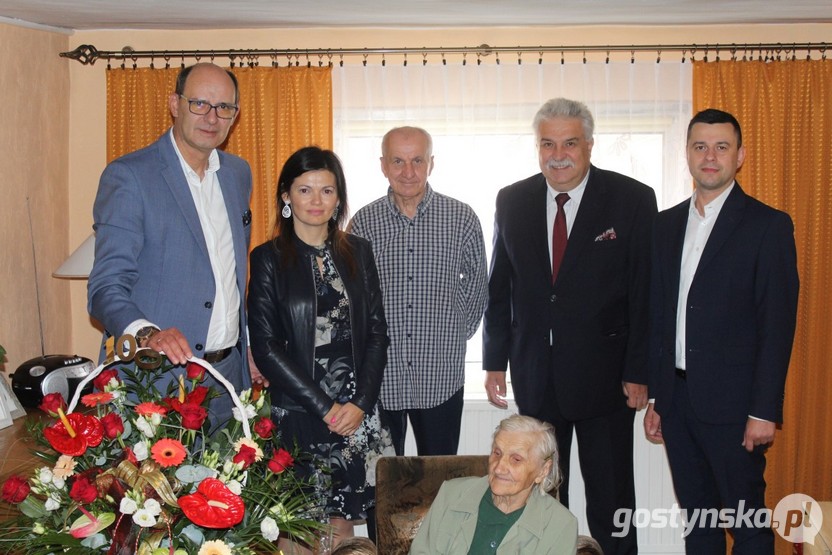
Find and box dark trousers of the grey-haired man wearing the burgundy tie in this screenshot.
[520,376,638,555]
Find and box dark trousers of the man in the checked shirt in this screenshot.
[385,387,465,456]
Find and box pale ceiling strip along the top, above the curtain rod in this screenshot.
[0,0,832,30]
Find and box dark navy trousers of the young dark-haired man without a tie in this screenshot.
[661,377,774,555]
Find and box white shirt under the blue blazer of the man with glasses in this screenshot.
[124,128,241,352]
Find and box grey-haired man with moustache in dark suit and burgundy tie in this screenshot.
[483,98,657,555]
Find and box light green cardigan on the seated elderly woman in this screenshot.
[410,477,578,555]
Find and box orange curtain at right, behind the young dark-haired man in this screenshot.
[693,60,832,554]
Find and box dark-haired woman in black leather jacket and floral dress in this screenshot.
[248,147,394,553]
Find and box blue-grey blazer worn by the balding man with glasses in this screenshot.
[87,131,251,380]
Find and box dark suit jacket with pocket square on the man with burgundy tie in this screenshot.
[483,166,656,420]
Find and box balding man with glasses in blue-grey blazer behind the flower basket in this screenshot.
[88,63,252,427]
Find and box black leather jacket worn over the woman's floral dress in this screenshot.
[248,235,390,418]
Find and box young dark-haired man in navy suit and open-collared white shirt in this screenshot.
[644,109,799,555]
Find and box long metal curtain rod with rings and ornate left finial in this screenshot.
[59,42,832,67]
